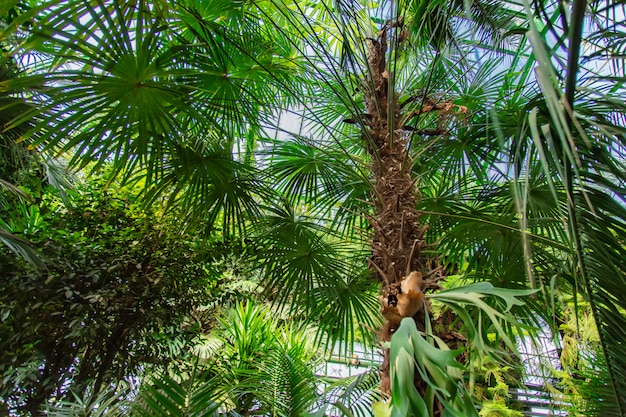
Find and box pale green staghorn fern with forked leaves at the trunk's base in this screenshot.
[379,282,533,417]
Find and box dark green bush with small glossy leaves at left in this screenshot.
[0,178,219,411]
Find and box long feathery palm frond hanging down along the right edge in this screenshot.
[516,2,626,414]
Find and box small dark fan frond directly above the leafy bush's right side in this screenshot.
[138,141,273,238]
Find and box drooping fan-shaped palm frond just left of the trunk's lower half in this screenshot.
[255,202,378,343]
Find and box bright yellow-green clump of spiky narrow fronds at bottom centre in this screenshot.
[204,303,317,416]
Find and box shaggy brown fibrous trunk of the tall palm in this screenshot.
[364,22,436,410]
